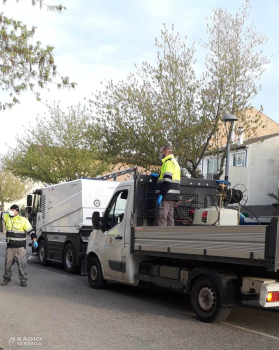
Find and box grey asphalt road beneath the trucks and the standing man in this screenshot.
[0,234,279,350]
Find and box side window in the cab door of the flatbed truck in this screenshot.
[106,190,128,230]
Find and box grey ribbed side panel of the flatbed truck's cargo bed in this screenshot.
[133,218,279,272]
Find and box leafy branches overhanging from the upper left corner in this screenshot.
[0,0,75,110]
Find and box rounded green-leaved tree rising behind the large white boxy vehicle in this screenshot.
[3,105,109,184]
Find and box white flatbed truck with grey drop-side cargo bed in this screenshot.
[86,168,279,322]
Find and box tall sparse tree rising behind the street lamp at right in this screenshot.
[203,1,270,178]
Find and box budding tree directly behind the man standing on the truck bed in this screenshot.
[92,27,207,176]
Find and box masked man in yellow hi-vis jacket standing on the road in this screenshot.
[0,204,38,287]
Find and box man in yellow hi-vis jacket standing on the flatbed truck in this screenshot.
[151,144,180,226]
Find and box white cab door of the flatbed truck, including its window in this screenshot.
[103,189,129,280]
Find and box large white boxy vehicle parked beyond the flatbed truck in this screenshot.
[27,179,119,274]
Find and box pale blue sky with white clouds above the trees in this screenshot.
[0,0,279,154]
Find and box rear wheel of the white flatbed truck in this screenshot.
[191,276,232,323]
